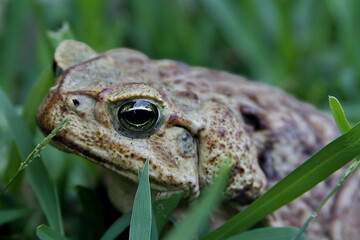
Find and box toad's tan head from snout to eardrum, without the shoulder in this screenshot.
[37,40,199,196]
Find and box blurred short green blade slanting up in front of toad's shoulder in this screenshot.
[166,159,229,240]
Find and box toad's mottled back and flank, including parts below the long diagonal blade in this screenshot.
[152,60,360,239]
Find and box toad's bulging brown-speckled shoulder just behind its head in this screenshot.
[198,102,266,204]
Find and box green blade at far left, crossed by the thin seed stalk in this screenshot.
[0,89,64,233]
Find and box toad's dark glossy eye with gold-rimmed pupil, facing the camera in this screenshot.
[117,100,160,137]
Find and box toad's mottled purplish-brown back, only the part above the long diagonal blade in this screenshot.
[152,60,339,180]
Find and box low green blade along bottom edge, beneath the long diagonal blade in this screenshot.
[227,227,307,240]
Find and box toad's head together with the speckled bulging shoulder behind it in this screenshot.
[37,40,264,198]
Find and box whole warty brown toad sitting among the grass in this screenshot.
[36,40,360,239]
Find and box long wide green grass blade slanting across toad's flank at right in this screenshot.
[203,124,360,240]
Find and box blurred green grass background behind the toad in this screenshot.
[0,0,360,238]
